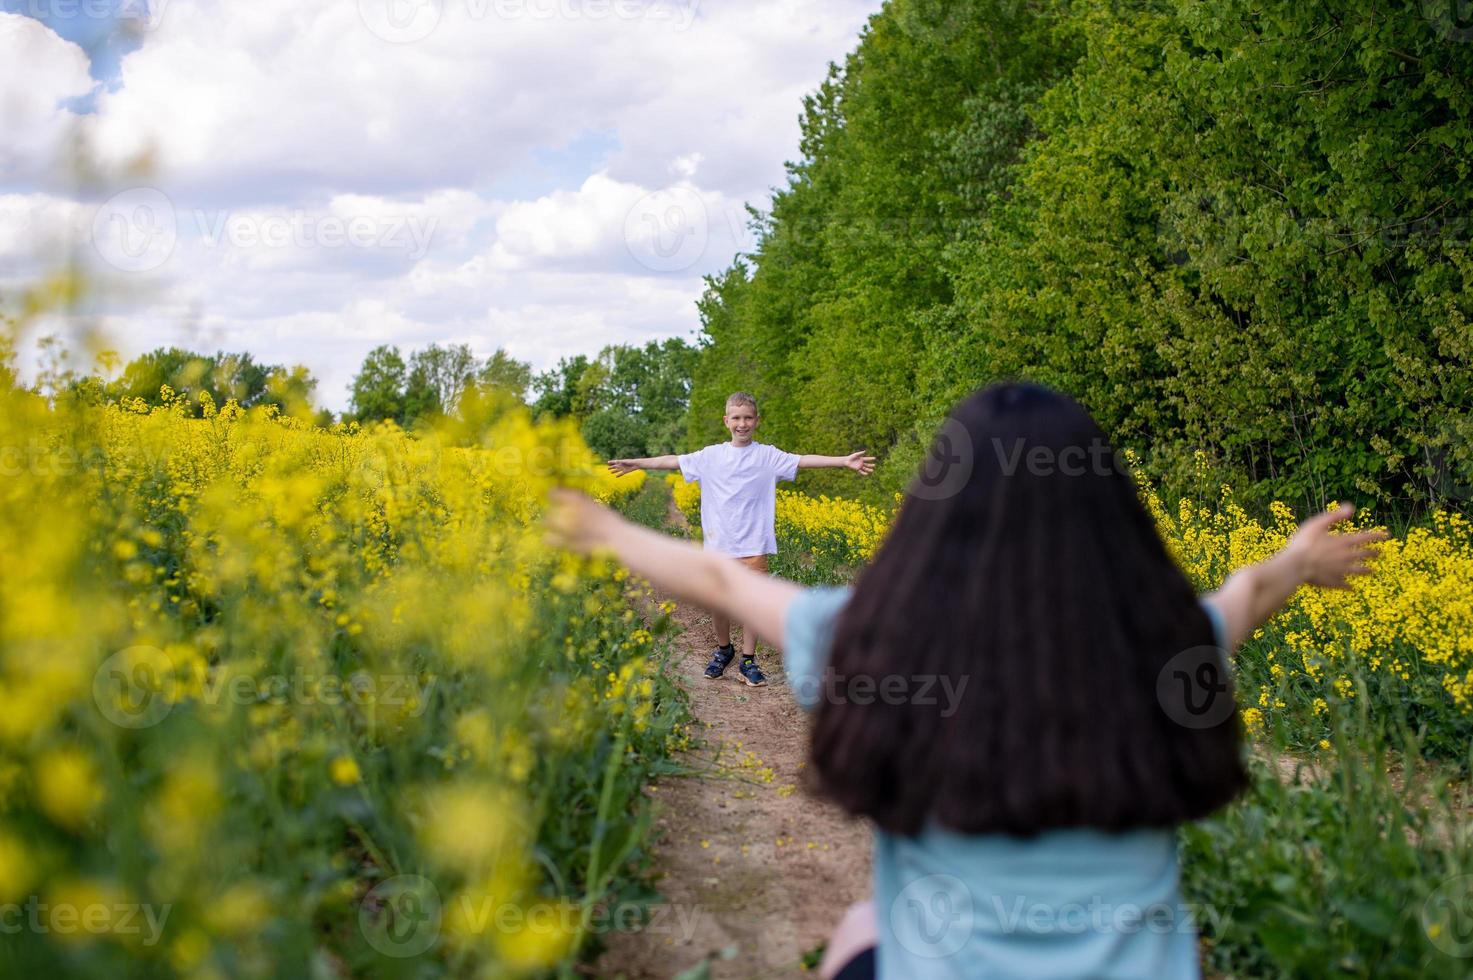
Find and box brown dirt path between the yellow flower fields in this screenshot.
[597,504,871,980]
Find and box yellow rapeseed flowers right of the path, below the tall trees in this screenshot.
[667,465,1473,752]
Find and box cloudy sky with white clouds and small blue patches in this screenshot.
[0,0,881,410]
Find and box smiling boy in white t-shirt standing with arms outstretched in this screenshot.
[608,392,875,687]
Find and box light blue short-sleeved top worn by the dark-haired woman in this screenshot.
[784,588,1226,980]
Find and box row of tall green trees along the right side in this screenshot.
[688,0,1473,510]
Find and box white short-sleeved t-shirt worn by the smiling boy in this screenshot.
[679,442,800,559]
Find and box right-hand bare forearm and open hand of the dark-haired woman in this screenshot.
[1205,504,1388,650]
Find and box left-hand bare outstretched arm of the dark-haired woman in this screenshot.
[546,488,803,650]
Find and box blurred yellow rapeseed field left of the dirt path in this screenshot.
[0,392,686,979]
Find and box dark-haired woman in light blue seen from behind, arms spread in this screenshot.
[552,385,1385,980]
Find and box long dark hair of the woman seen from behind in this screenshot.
[812,385,1248,836]
